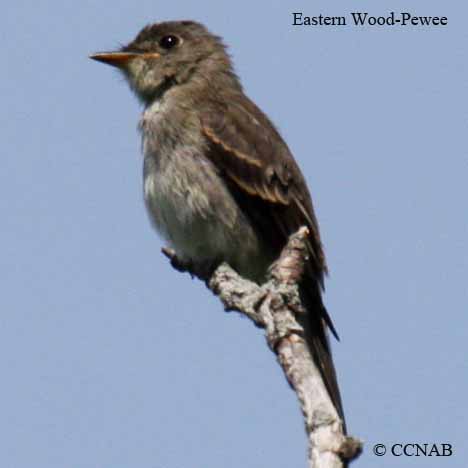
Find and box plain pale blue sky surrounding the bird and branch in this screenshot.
[0,0,468,468]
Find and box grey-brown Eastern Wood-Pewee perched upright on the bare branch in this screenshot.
[90,21,345,425]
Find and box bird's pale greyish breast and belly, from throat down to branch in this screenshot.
[141,100,271,279]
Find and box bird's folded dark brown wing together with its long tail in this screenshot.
[201,95,344,421]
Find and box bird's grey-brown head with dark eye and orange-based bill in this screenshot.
[90,21,237,104]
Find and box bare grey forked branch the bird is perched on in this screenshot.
[164,228,362,468]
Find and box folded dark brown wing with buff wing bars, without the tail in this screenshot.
[201,96,327,285]
